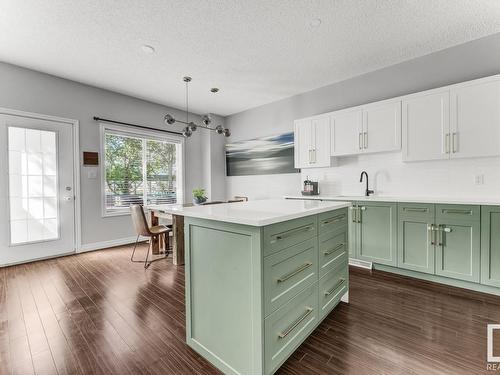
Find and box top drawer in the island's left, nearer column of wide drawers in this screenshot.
[264,215,318,256]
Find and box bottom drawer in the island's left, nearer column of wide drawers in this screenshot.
[264,283,318,374]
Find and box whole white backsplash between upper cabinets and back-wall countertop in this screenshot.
[226,152,500,199]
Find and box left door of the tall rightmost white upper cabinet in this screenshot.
[403,90,451,161]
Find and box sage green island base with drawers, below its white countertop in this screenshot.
[185,207,349,375]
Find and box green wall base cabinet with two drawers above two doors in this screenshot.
[398,203,481,283]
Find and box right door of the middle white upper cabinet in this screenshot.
[363,100,401,152]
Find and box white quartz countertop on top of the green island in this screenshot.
[146,199,351,227]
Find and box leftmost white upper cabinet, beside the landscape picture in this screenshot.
[294,115,330,168]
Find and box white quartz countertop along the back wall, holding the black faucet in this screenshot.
[284,194,500,206]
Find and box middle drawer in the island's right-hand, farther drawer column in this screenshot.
[319,228,349,277]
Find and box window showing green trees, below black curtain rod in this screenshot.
[101,125,183,216]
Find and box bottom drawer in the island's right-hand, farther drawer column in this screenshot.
[319,265,348,319]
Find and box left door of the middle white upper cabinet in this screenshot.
[330,108,363,156]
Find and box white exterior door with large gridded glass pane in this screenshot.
[0,115,75,265]
